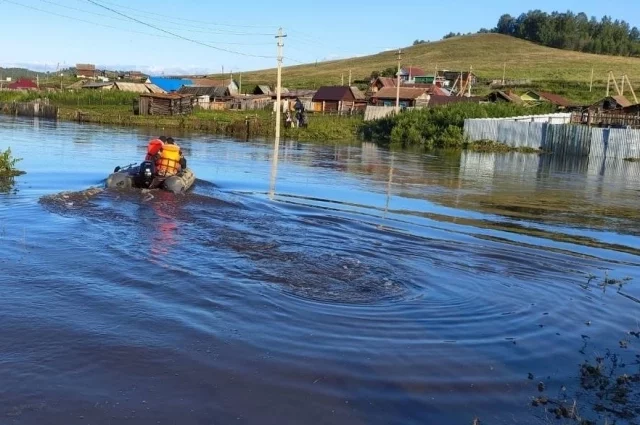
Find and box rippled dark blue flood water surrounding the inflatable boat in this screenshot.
[0,117,640,425]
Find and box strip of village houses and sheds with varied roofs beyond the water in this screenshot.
[0,64,640,125]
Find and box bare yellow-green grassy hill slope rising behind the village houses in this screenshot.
[217,34,640,91]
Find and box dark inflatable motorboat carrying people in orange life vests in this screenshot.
[106,161,196,193]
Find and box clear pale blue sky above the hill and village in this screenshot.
[0,0,640,75]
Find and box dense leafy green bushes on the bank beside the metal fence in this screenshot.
[362,103,552,151]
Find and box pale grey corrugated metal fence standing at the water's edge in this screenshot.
[464,114,640,158]
